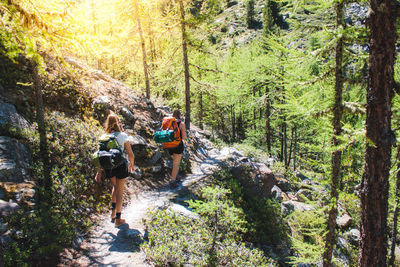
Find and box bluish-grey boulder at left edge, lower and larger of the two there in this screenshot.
[0,136,30,183]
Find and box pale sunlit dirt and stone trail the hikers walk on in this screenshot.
[58,147,218,267]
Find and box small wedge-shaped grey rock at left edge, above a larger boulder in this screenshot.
[0,100,29,134]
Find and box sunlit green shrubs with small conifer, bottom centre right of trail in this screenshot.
[143,187,273,266]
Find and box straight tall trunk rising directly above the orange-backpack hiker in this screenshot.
[179,0,190,130]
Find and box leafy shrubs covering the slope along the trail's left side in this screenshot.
[5,113,109,265]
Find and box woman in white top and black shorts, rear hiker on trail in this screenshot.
[95,114,135,226]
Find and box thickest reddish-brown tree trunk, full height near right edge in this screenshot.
[359,0,397,267]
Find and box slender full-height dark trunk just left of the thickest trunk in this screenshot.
[323,1,344,267]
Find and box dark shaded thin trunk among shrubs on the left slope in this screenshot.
[32,62,52,201]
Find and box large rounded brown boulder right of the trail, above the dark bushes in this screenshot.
[232,163,276,197]
